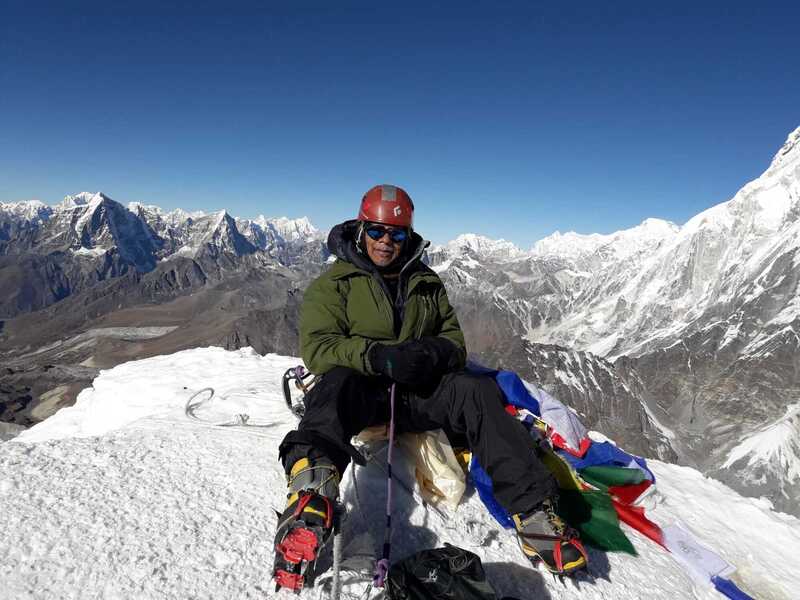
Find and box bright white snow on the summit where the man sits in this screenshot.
[0,348,800,600]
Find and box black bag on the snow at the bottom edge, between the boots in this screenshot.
[386,544,515,600]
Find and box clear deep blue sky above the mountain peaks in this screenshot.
[0,0,800,246]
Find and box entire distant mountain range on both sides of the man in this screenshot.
[0,128,800,514]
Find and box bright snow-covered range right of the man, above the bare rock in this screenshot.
[429,128,800,357]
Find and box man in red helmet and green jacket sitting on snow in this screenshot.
[275,185,586,585]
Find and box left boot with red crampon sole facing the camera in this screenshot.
[273,457,339,592]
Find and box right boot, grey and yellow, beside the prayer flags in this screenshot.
[512,499,588,575]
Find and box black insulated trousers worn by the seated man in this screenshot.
[280,367,557,514]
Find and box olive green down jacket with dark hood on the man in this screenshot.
[300,221,466,375]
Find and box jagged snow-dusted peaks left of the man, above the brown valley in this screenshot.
[0,192,328,317]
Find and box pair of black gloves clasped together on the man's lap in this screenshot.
[368,337,456,386]
